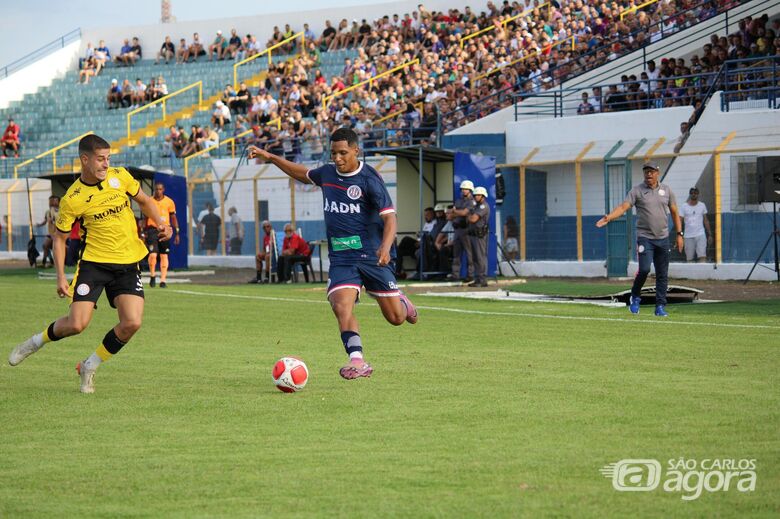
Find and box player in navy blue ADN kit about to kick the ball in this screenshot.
[248,128,417,379]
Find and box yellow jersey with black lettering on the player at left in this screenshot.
[57,168,149,265]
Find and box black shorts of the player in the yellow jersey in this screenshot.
[70,260,144,308]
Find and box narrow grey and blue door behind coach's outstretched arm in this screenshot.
[604,160,633,277]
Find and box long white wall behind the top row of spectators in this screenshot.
[80,0,476,58]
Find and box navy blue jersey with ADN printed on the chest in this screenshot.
[307,162,395,265]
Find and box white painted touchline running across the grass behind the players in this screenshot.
[168,290,780,330]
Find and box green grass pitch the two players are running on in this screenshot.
[0,271,780,518]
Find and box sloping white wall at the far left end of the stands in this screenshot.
[0,41,81,108]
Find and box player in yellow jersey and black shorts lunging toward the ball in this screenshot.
[8,135,173,393]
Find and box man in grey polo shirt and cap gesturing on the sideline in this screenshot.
[596,162,683,317]
